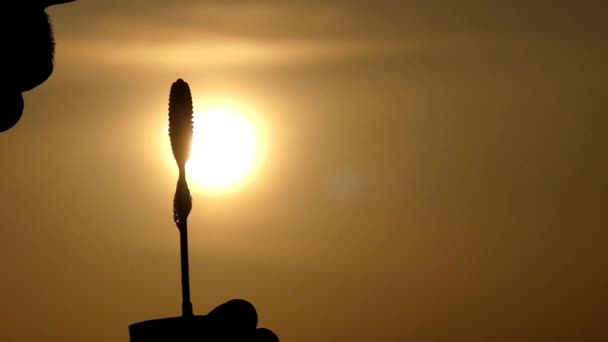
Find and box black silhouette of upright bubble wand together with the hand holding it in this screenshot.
[129,78,279,342]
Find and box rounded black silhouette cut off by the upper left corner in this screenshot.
[0,0,75,132]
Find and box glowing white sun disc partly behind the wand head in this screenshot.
[186,104,259,192]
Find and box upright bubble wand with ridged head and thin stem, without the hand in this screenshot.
[169,78,193,316]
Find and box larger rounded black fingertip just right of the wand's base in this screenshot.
[207,299,258,332]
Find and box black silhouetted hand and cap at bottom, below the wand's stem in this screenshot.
[129,299,279,342]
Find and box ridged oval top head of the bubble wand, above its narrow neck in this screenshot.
[169,78,192,170]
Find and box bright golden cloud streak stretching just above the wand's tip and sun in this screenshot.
[62,39,410,69]
